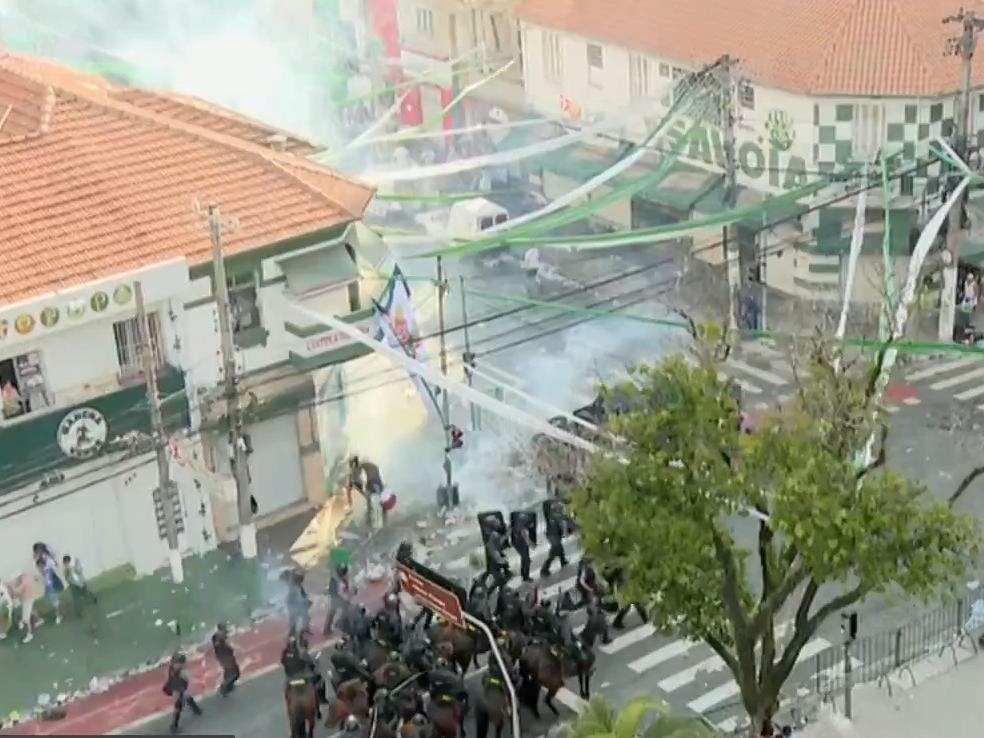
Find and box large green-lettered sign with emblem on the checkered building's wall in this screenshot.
[649,110,809,190]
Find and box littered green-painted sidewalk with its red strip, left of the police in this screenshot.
[0,488,360,733]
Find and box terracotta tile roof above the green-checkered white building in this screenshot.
[519,0,984,97]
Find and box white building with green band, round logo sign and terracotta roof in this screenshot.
[0,55,385,578]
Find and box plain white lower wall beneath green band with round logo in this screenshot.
[0,446,216,580]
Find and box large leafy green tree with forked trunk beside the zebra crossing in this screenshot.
[572,346,979,726]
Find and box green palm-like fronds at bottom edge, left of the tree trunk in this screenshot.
[567,697,714,738]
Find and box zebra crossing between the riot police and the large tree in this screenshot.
[427,524,844,732]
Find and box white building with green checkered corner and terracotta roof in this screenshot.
[518,0,984,299]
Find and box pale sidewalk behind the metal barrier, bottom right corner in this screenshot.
[800,651,984,738]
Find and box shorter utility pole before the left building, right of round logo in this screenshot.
[133,282,184,584]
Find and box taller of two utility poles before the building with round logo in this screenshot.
[208,204,256,559]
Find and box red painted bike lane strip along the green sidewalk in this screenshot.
[0,583,386,735]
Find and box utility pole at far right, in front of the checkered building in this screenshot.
[938,10,984,342]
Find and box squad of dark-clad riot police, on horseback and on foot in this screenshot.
[164,504,646,738]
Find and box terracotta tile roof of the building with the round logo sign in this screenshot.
[0,55,373,304]
